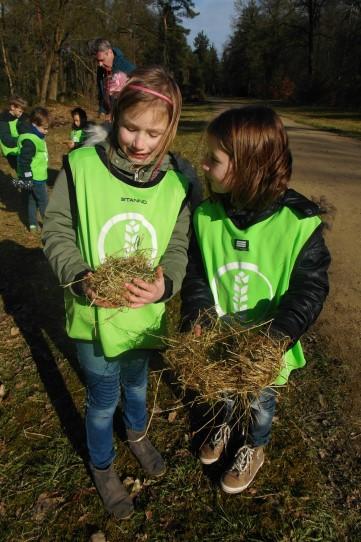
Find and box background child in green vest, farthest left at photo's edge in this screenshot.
[0,96,27,171]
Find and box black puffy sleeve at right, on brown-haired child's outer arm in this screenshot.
[271,225,331,346]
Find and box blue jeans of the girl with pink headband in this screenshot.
[76,341,152,468]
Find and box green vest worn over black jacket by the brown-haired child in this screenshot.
[194,200,321,385]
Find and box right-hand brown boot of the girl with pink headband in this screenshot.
[127,429,166,476]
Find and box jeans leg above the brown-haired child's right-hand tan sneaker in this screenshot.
[247,388,276,447]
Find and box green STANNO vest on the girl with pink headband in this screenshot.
[65,147,188,357]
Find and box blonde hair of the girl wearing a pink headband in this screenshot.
[110,66,182,163]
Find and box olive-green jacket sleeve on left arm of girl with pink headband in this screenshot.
[42,169,90,285]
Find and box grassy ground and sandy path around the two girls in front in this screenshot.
[0,100,361,542]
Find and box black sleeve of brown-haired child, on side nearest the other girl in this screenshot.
[181,230,214,331]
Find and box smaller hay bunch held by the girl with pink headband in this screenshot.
[87,250,155,307]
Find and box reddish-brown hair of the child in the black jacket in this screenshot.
[207,105,292,210]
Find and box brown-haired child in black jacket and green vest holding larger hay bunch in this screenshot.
[182,106,330,493]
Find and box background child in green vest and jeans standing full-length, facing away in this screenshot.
[14,107,49,232]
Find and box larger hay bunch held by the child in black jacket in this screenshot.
[165,318,289,408]
